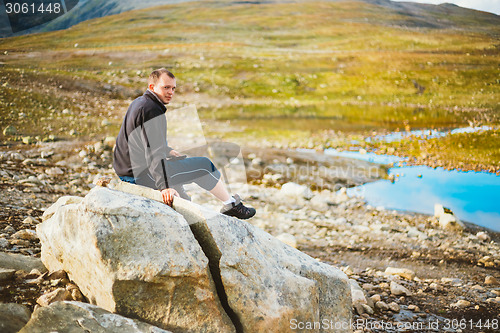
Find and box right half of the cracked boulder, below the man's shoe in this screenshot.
[173,192,352,332]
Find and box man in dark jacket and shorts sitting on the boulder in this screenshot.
[113,68,255,219]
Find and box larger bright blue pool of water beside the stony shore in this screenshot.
[348,164,500,231]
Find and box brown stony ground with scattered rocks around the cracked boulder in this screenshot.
[0,141,500,332]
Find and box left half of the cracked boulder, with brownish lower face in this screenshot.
[37,187,234,332]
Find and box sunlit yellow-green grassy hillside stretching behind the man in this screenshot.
[0,1,500,171]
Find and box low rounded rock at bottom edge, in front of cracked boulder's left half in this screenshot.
[19,301,169,333]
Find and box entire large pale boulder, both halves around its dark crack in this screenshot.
[37,183,351,333]
